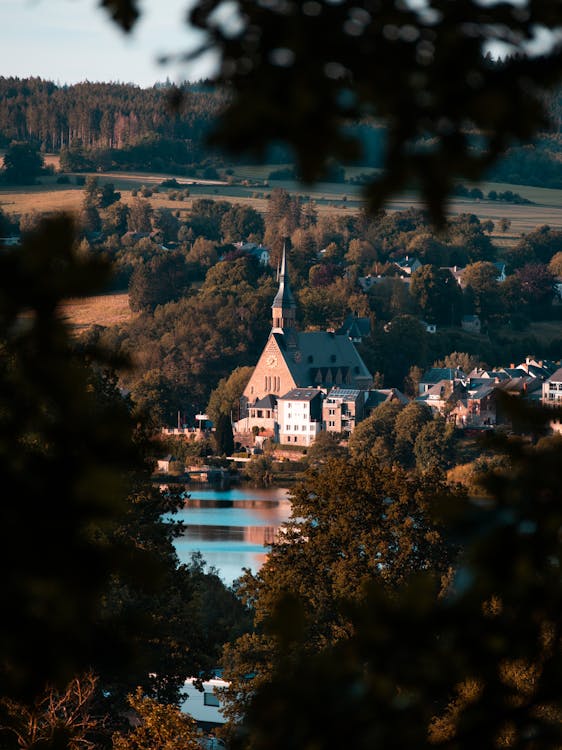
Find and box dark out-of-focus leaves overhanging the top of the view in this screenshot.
[104,0,562,222]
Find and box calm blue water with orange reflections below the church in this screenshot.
[174,487,291,585]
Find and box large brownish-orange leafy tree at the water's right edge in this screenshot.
[222,457,461,736]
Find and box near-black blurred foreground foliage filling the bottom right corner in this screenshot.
[220,400,562,750]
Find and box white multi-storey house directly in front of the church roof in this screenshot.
[277,388,325,446]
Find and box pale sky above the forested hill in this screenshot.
[0,0,218,88]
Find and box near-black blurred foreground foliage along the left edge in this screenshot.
[0,217,155,699]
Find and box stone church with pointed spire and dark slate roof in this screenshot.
[235,249,372,440]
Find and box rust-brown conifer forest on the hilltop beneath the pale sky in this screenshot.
[0,77,226,152]
